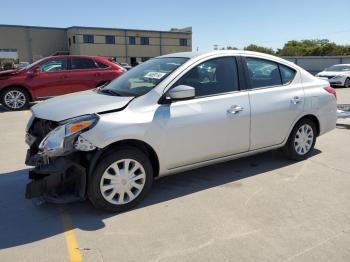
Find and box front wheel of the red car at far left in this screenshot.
[0,87,29,111]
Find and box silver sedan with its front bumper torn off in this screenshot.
[26,51,337,211]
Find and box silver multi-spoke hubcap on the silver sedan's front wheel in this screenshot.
[100,159,146,205]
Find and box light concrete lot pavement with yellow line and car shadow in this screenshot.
[0,88,350,262]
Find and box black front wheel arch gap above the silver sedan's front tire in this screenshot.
[88,139,159,177]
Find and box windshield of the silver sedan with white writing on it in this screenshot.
[100,57,188,96]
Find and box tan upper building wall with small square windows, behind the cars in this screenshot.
[67,27,192,63]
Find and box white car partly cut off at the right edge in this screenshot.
[316,64,350,87]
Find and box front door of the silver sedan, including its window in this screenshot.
[162,57,250,169]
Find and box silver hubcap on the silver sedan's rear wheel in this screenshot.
[294,124,314,155]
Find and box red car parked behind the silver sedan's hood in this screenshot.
[0,55,126,110]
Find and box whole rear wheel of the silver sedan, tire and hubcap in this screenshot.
[283,118,317,161]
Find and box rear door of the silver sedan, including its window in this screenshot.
[244,57,304,150]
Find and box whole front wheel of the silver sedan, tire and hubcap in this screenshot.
[88,147,153,212]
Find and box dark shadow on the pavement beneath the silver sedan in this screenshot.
[0,149,320,249]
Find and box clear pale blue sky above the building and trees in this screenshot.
[0,0,350,51]
